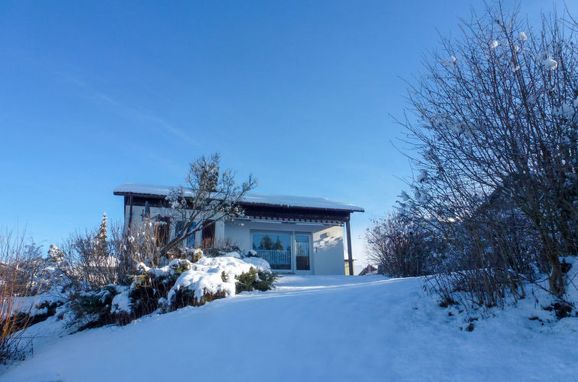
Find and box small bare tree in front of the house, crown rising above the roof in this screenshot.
[159,154,256,256]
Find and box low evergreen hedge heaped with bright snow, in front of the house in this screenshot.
[66,252,276,329]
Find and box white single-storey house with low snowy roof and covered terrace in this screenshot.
[114,184,364,275]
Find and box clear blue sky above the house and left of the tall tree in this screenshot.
[0,0,568,268]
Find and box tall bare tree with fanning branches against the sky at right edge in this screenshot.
[407,6,578,297]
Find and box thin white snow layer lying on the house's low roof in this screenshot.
[114,184,365,212]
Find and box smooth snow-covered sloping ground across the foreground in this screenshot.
[0,276,578,382]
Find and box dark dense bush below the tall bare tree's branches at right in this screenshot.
[428,192,547,307]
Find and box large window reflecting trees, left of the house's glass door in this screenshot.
[253,232,292,270]
